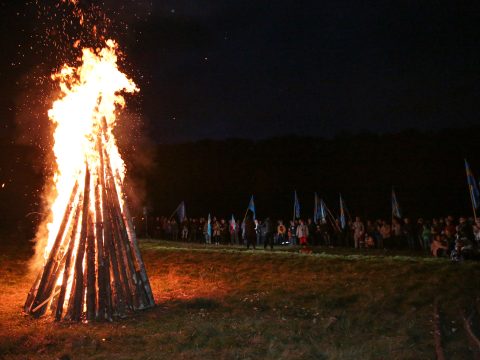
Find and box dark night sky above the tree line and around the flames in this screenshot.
[0,0,480,143]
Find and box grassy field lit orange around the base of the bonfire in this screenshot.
[0,241,480,359]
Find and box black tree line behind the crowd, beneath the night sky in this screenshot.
[138,128,480,219]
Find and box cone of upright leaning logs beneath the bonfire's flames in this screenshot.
[24,126,154,321]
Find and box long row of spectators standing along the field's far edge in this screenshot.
[145,214,480,260]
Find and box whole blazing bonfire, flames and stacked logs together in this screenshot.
[25,41,154,321]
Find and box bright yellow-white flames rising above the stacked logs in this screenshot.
[44,40,139,259]
